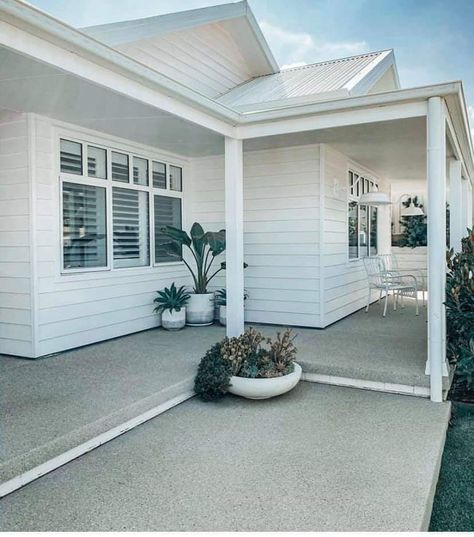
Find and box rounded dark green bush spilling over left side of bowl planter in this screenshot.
[194,343,232,401]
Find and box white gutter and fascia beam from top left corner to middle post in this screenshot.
[0,0,239,130]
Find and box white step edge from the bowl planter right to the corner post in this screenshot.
[301,373,430,397]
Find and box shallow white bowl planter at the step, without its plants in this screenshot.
[229,363,302,399]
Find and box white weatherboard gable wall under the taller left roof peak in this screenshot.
[115,24,252,97]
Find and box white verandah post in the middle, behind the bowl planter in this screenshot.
[225,137,244,337]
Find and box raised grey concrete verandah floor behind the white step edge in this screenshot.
[0,298,442,494]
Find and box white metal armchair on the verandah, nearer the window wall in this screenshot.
[363,256,419,317]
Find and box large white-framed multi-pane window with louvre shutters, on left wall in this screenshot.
[60,139,183,271]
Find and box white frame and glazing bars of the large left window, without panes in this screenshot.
[55,133,187,275]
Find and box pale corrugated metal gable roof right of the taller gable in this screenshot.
[217,50,400,111]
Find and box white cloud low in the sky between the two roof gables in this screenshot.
[259,20,368,68]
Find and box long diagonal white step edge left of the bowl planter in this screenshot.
[0,391,194,498]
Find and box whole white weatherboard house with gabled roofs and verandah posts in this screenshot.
[0,0,474,401]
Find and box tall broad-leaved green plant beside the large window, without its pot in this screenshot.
[160,222,225,295]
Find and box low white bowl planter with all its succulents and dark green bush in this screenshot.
[194,328,302,401]
